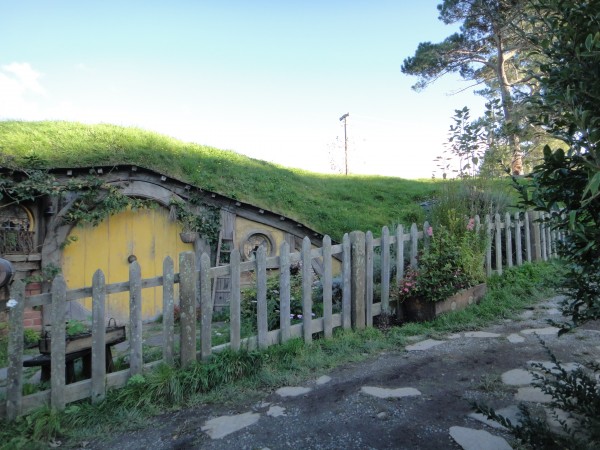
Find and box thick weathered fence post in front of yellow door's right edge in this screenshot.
[179,252,196,367]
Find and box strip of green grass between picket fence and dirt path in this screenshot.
[0,263,562,450]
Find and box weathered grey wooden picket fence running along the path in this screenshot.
[0,209,561,420]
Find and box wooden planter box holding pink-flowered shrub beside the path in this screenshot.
[402,283,487,322]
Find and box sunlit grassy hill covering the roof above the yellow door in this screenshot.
[0,121,439,240]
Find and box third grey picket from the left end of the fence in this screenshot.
[91,269,106,404]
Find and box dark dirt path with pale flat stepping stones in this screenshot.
[86,299,600,450]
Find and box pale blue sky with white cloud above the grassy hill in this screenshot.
[0,0,483,178]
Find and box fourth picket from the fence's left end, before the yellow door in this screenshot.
[129,261,144,375]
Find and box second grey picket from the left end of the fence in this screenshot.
[50,274,67,411]
